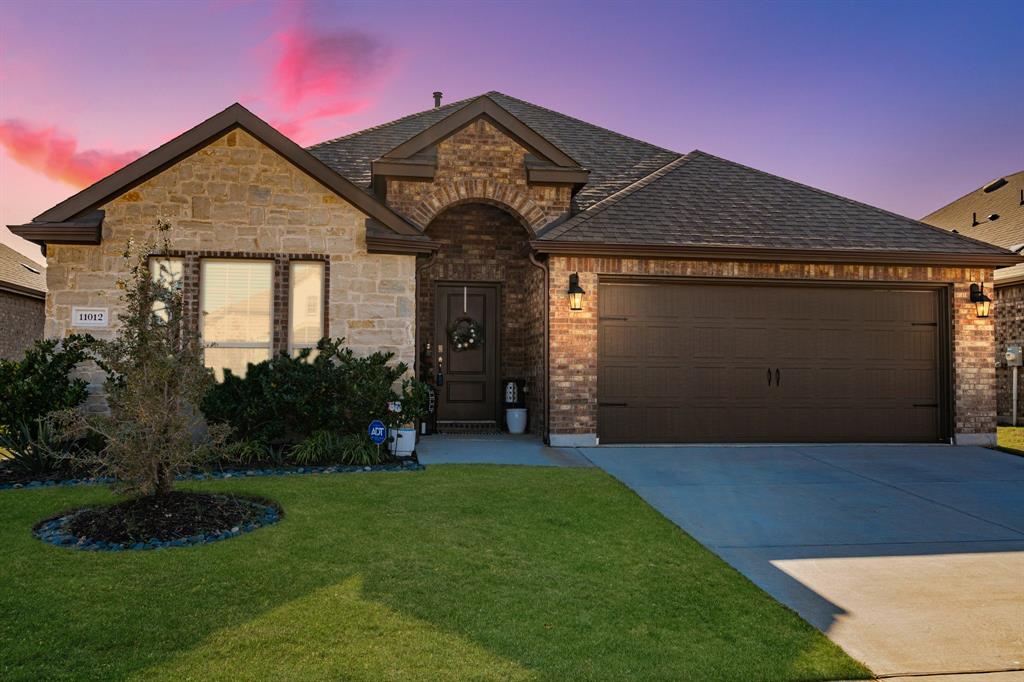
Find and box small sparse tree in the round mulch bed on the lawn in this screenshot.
[56,221,227,496]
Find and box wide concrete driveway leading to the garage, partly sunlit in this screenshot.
[583,445,1024,682]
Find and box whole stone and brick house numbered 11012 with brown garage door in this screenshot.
[11,92,1021,445]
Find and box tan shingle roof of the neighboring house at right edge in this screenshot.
[921,171,1024,284]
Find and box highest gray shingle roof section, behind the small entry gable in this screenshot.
[309,92,680,210]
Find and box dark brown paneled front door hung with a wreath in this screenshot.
[434,284,499,422]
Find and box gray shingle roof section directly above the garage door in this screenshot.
[540,151,1006,255]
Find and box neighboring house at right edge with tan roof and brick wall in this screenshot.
[922,171,1024,424]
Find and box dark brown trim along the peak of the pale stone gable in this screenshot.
[23,102,421,236]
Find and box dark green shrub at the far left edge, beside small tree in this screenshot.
[0,335,91,473]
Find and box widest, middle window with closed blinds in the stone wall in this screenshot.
[200,259,273,381]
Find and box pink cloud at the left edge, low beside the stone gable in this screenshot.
[0,119,143,187]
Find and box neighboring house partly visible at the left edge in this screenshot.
[0,244,46,359]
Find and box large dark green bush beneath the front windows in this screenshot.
[202,339,426,445]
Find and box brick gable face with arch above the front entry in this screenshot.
[387,119,572,231]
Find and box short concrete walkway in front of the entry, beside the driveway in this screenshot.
[416,433,594,467]
